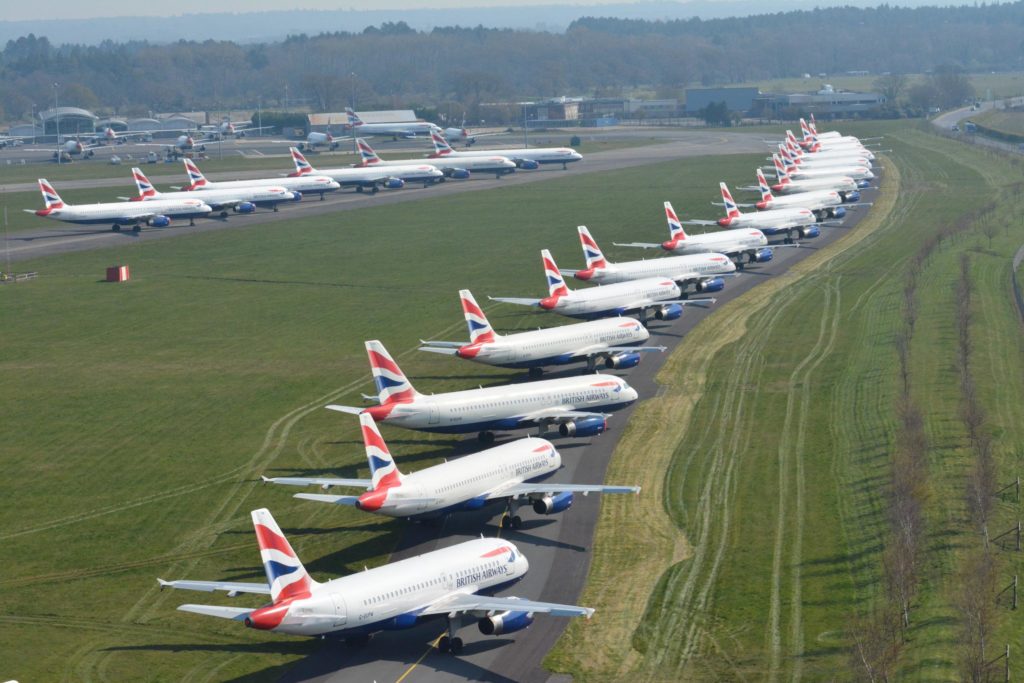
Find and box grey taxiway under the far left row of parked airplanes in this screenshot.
[3,131,765,262]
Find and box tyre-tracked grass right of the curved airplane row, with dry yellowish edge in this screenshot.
[549,126,1024,681]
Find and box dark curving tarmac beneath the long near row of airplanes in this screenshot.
[280,183,880,683]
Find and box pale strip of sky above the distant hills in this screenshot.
[2,0,640,22]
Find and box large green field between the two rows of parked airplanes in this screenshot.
[0,150,758,682]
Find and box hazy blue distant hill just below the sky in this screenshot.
[0,0,942,45]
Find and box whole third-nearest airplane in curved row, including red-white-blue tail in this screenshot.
[327,341,637,442]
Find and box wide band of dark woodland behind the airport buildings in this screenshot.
[0,2,1024,121]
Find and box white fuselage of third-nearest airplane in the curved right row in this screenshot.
[364,375,638,434]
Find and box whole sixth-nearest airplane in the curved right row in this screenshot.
[560,225,736,296]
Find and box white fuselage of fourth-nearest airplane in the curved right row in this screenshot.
[455,317,650,368]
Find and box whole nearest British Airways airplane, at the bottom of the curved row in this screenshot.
[157,508,594,654]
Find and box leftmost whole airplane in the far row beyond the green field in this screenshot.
[25,178,213,232]
